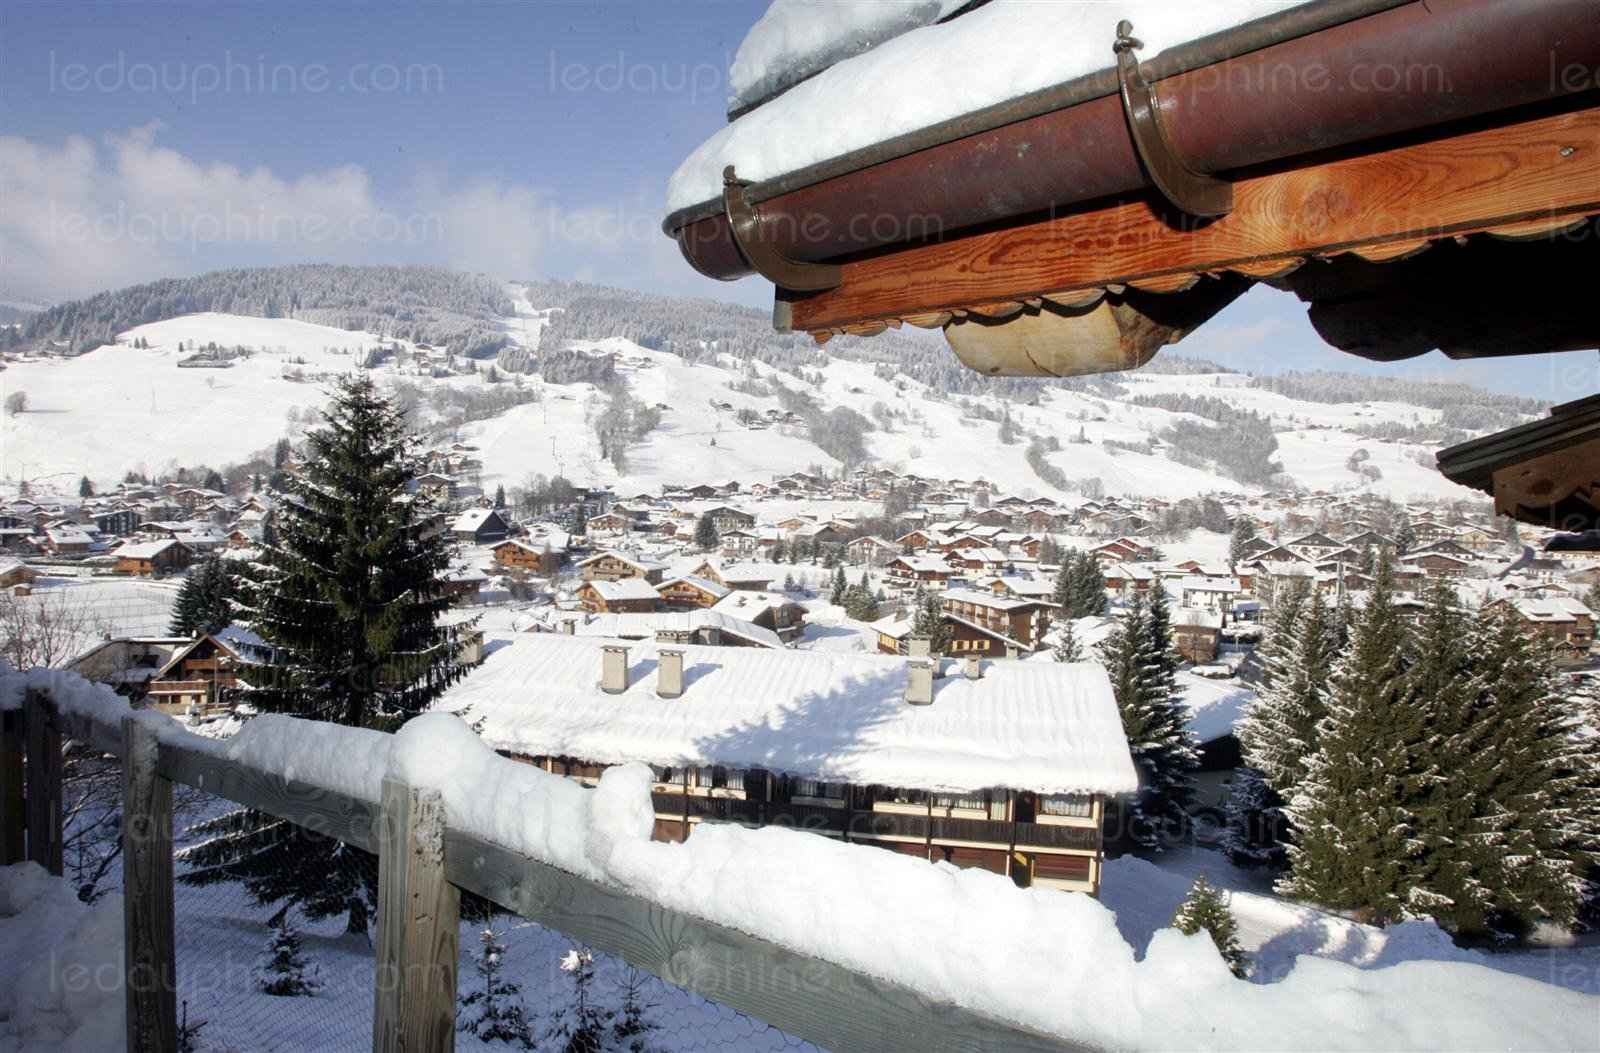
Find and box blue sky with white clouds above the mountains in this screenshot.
[0,0,1574,400]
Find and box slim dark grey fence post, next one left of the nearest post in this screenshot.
[122,717,178,1053]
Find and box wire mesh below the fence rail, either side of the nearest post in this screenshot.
[164,791,816,1053]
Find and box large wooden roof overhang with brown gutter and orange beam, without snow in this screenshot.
[664,0,1600,374]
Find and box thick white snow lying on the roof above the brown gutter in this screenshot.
[667,0,1298,211]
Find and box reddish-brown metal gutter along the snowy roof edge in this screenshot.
[662,0,1600,280]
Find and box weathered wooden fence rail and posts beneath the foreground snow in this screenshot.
[0,693,1088,1053]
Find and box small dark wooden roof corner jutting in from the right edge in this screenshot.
[1438,395,1600,537]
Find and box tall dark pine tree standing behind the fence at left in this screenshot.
[181,376,467,931]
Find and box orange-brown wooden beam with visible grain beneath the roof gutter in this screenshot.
[781,106,1600,333]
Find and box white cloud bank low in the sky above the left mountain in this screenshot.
[0,122,739,302]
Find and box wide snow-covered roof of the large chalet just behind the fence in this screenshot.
[440,634,1138,794]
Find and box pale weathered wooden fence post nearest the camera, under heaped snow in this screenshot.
[373,779,461,1053]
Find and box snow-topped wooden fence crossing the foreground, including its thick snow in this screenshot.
[0,671,1600,1050]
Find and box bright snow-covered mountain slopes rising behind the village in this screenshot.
[0,286,1516,499]
